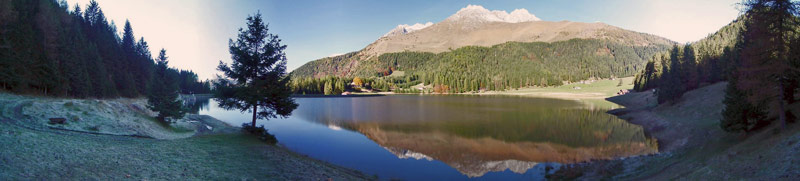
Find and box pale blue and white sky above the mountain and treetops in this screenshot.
[67,0,740,79]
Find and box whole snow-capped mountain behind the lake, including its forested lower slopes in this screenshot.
[291,5,675,92]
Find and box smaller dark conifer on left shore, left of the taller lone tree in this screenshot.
[147,49,186,122]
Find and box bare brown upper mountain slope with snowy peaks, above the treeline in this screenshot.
[361,5,672,56]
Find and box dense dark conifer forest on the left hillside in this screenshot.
[0,0,210,98]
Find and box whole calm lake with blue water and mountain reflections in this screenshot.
[194,95,658,180]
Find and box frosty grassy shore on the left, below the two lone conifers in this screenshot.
[0,94,373,180]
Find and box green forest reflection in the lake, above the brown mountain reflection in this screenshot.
[294,96,648,147]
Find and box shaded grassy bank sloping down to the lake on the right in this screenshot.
[548,83,800,180]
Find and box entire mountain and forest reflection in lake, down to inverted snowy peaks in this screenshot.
[192,95,658,177]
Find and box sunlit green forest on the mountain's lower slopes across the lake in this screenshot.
[291,39,669,93]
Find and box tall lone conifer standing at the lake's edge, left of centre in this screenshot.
[214,13,297,127]
